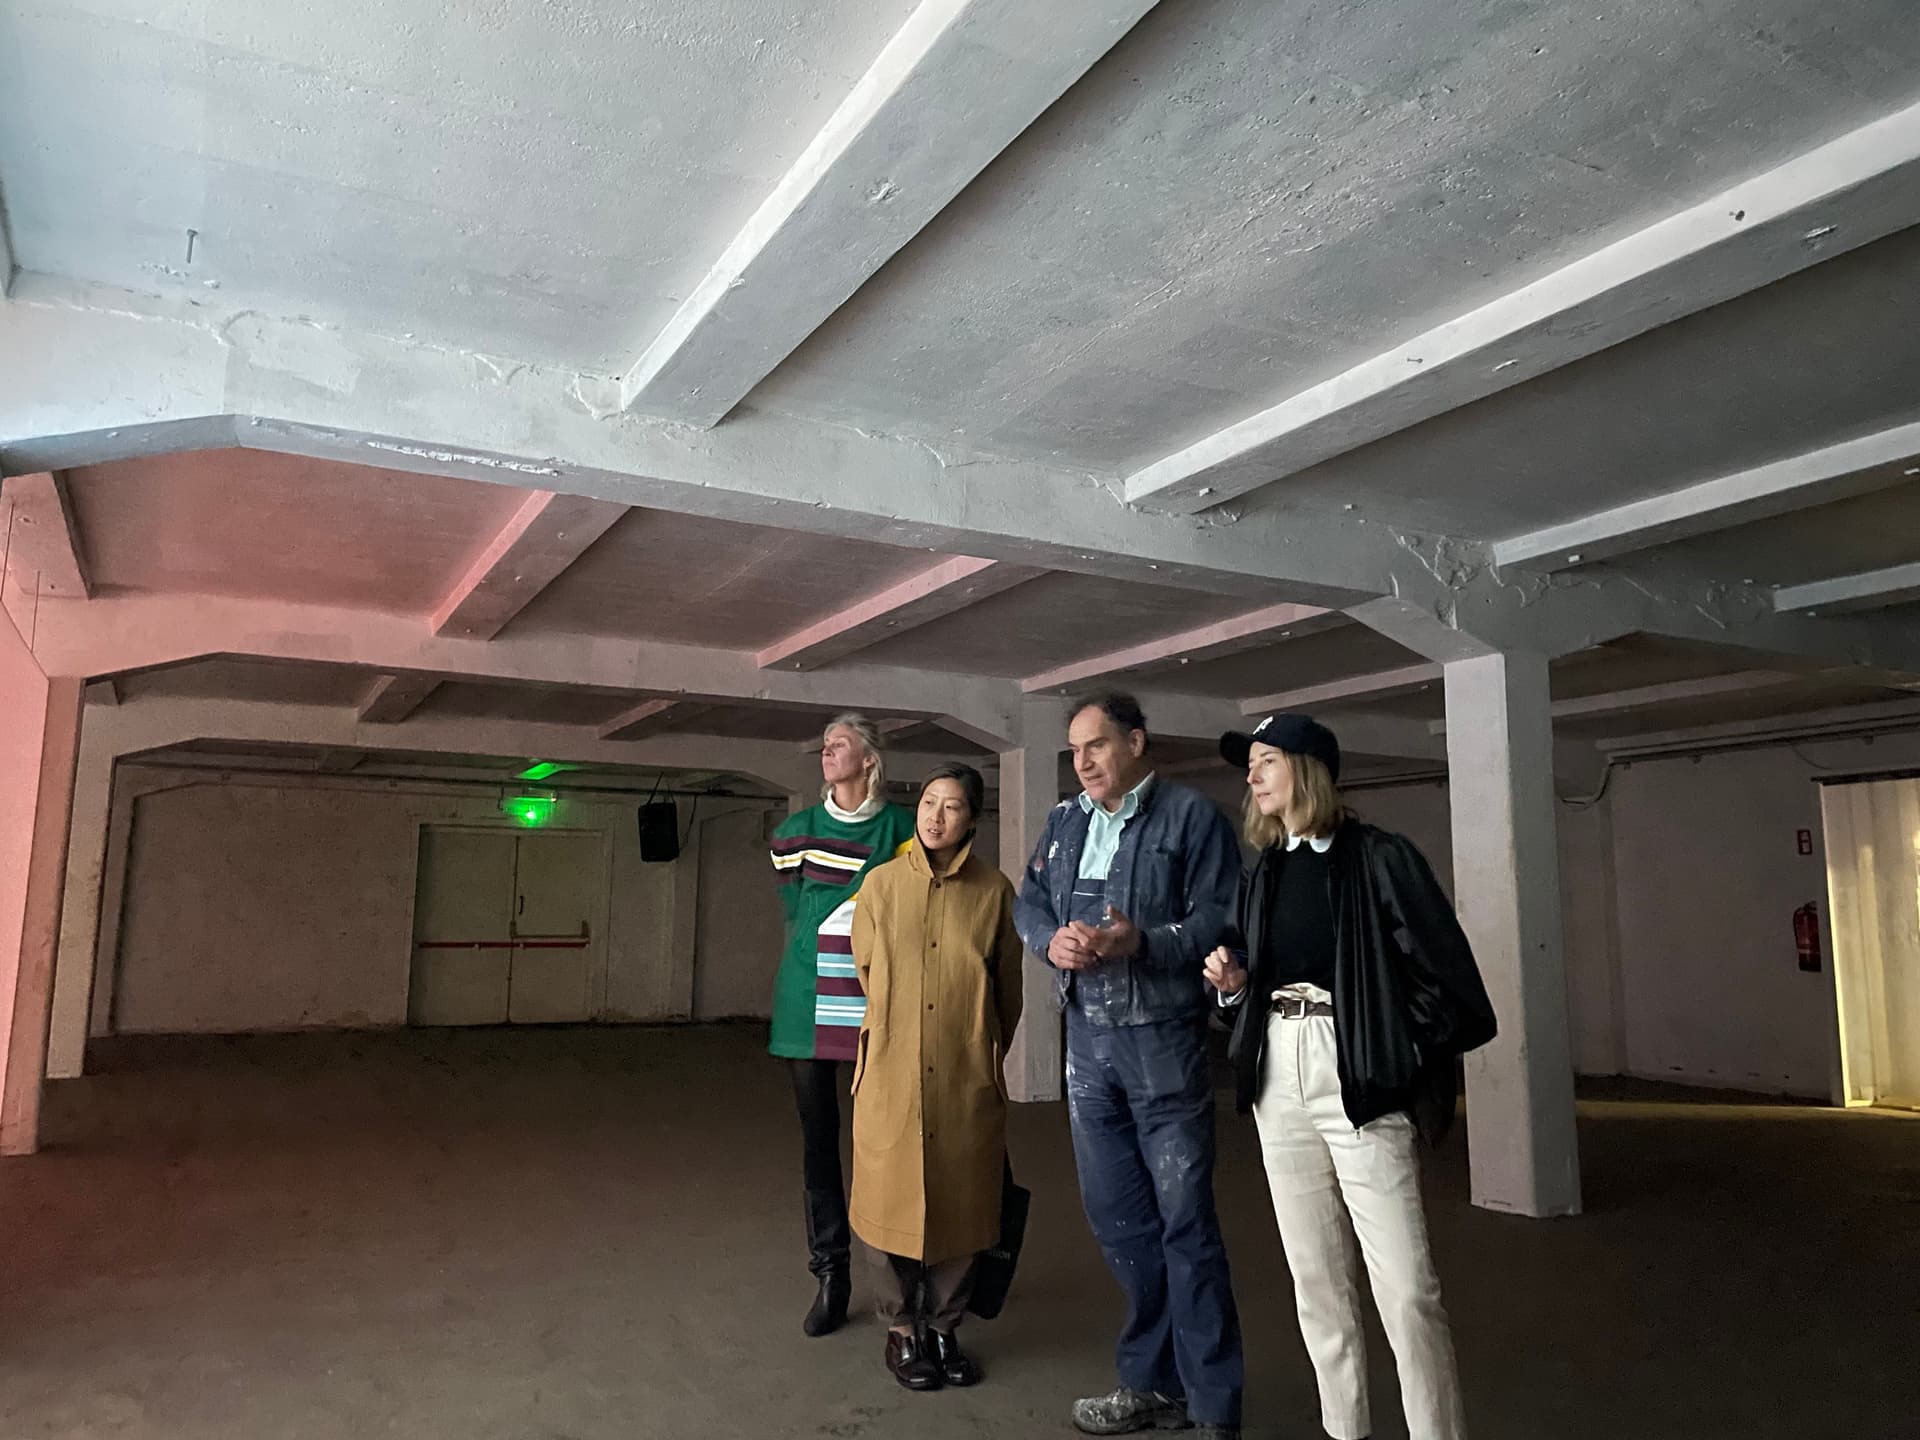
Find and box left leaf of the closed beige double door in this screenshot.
[407,829,518,1025]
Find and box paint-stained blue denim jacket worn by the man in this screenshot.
[1014,778,1240,1025]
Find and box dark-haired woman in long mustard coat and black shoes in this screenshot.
[849,764,1023,1390]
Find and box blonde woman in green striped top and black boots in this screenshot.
[768,714,914,1336]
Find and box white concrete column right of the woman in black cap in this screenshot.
[1446,653,1580,1215]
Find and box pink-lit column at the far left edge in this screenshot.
[0,609,83,1156]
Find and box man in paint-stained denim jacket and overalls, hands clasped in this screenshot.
[1014,691,1244,1436]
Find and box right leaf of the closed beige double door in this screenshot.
[507,833,607,1025]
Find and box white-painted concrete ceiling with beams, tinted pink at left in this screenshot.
[0,0,1920,774]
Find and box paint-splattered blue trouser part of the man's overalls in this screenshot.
[1068,1004,1244,1425]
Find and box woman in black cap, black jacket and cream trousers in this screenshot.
[1206,714,1494,1440]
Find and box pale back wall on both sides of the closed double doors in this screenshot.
[95,766,778,1033]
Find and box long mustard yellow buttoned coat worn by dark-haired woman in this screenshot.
[849,841,1023,1265]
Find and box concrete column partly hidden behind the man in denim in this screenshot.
[1000,699,1068,1100]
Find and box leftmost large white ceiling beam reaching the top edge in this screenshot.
[620,0,1154,426]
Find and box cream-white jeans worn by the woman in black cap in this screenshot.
[1254,987,1465,1440]
